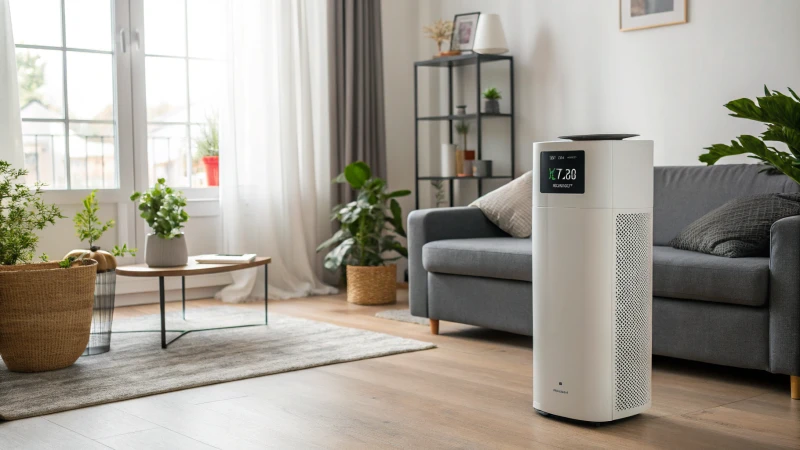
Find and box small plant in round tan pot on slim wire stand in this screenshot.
[64,190,136,355]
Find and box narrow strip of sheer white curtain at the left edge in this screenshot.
[0,0,24,169]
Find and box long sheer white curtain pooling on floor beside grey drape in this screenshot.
[217,0,336,302]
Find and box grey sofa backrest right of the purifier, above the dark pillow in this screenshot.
[653,164,800,245]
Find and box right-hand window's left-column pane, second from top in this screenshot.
[145,57,188,122]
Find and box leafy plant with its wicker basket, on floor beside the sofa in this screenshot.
[317,161,411,305]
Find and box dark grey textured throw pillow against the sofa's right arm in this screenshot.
[669,194,800,258]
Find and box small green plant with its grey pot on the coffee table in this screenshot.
[131,178,189,267]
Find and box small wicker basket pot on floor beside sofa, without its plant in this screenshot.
[347,264,397,305]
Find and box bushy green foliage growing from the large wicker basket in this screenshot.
[0,161,64,265]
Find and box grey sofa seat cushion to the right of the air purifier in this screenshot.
[653,246,769,306]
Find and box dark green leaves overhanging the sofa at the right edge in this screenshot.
[700,86,800,183]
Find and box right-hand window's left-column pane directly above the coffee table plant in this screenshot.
[147,125,191,187]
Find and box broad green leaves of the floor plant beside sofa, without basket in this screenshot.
[317,161,411,270]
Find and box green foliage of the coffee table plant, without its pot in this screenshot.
[131,178,189,239]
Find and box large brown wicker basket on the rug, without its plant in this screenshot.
[0,260,97,372]
